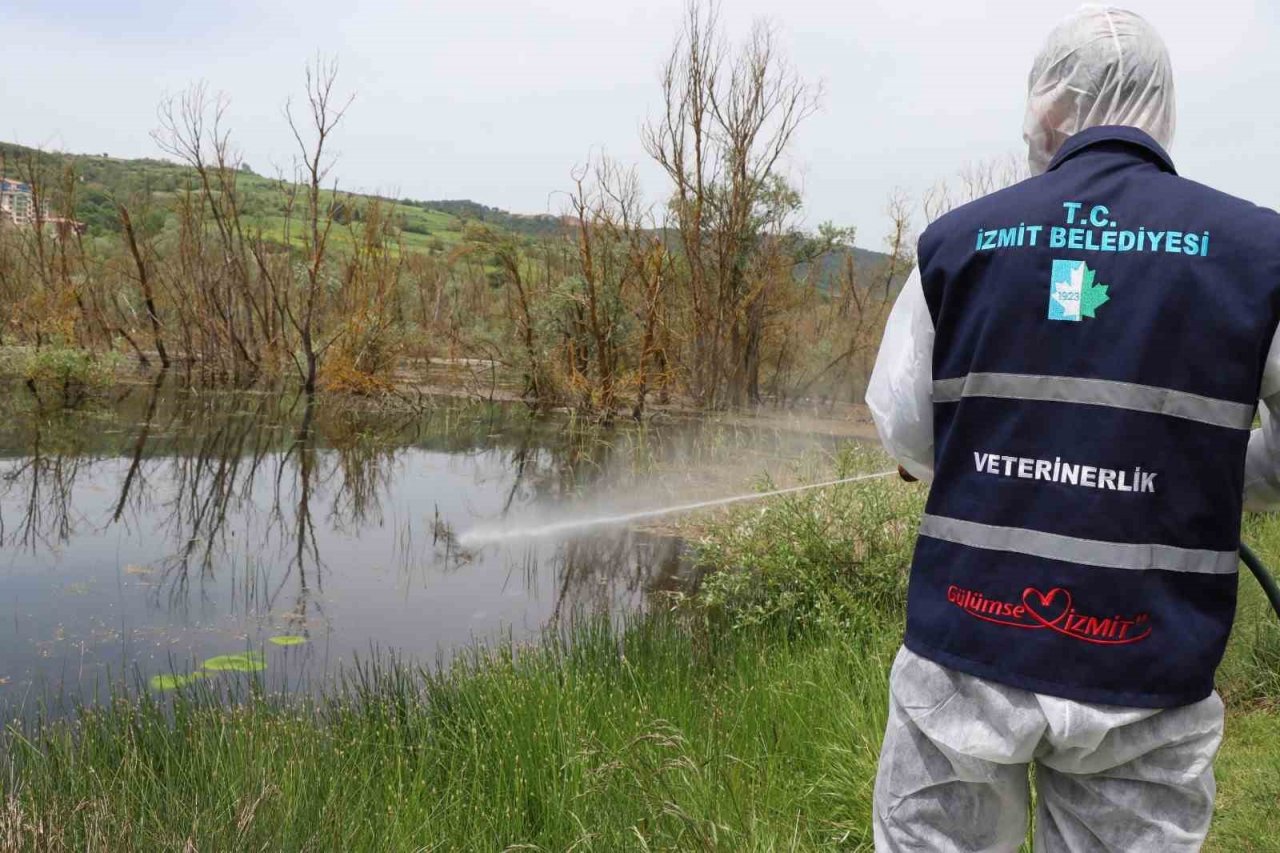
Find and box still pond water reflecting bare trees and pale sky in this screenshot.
[0,382,835,712]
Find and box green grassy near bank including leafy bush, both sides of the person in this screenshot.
[0,456,1280,850]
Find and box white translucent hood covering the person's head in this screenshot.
[1023,5,1175,174]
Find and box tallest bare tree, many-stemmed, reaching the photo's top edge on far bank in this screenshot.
[643,0,820,407]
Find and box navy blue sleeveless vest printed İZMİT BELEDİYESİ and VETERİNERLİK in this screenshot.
[906,127,1280,707]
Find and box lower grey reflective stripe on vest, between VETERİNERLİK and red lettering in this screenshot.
[920,515,1239,575]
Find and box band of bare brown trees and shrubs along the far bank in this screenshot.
[0,0,926,420]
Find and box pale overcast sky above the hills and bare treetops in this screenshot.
[0,0,1280,242]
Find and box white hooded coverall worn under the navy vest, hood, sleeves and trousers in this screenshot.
[867,5,1280,853]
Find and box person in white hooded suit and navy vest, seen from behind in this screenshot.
[867,6,1280,853]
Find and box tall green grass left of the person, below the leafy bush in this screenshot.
[0,615,895,850]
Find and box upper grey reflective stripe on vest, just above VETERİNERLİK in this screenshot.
[933,373,1254,429]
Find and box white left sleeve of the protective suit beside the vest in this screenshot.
[867,269,936,481]
